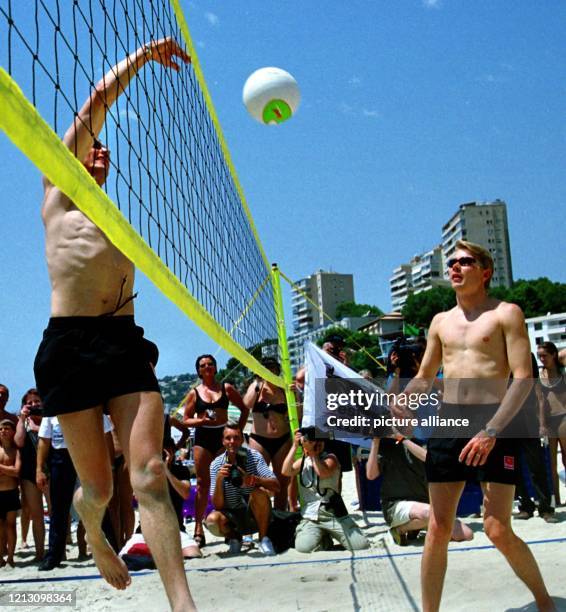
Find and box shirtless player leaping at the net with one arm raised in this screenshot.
[34,38,194,610]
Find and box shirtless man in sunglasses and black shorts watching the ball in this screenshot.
[393,241,554,612]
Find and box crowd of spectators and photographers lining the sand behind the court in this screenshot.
[0,337,566,571]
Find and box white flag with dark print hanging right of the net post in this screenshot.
[302,342,388,448]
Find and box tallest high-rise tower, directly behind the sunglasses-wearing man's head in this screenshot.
[442,200,513,287]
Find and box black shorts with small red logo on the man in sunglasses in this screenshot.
[425,404,519,485]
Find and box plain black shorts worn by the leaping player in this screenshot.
[34,316,159,416]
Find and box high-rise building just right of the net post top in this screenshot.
[291,270,354,334]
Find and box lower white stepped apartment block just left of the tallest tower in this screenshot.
[389,245,447,311]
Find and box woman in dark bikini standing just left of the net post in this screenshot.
[244,358,292,510]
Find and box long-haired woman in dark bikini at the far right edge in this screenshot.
[537,342,566,506]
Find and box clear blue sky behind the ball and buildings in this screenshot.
[0,0,566,410]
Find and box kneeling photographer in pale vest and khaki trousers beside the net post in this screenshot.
[282,427,369,553]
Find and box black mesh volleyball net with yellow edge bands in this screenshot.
[0,0,284,386]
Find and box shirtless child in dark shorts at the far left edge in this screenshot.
[0,419,21,567]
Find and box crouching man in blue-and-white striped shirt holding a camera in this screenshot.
[206,423,279,555]
